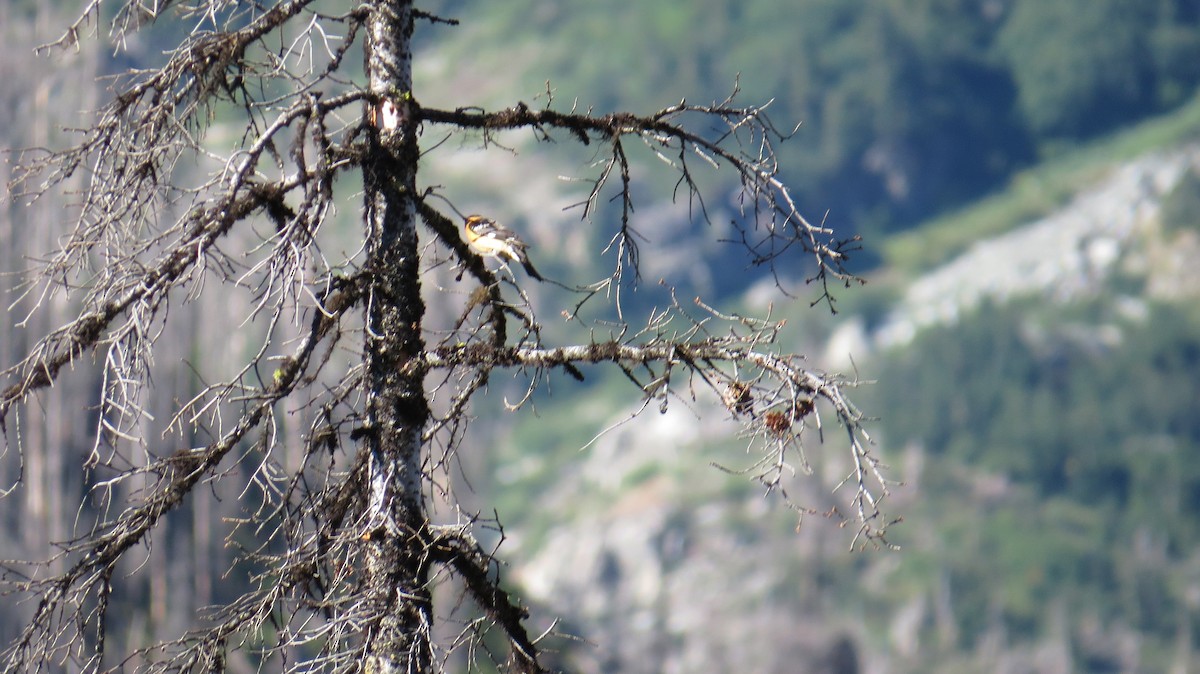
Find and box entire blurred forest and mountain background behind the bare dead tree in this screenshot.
[0,0,1200,674]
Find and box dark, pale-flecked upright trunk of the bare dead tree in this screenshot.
[360,0,432,673]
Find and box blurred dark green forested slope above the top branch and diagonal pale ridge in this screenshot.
[429,0,1200,247]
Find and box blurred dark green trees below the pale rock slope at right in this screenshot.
[868,302,1200,648]
